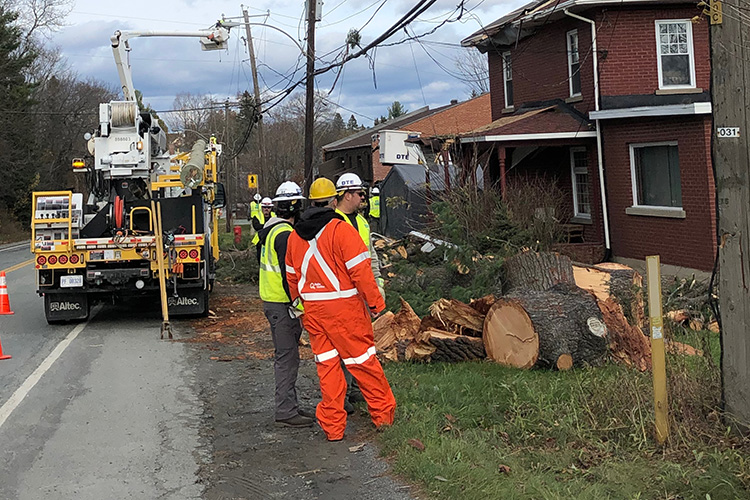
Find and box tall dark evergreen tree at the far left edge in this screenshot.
[0,4,42,220]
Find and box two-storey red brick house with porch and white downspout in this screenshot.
[461,0,716,270]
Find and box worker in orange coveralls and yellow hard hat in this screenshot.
[286,178,396,441]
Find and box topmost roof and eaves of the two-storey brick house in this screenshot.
[461,0,690,53]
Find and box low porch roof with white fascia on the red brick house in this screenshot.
[461,101,594,142]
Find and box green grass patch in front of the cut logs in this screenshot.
[379,342,750,500]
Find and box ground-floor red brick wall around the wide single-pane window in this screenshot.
[602,116,716,271]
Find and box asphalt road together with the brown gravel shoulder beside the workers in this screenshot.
[0,241,410,500]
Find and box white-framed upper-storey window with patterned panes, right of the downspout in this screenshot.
[656,20,695,89]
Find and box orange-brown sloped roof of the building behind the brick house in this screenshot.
[400,93,492,138]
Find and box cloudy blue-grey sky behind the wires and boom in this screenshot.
[50,0,524,125]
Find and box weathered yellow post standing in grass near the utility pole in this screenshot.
[646,255,669,444]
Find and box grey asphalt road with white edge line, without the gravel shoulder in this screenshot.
[0,246,203,499]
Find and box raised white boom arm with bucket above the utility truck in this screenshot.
[110,25,229,101]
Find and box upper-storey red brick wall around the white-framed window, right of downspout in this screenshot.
[596,7,711,95]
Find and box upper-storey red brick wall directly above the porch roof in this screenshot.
[489,18,594,120]
